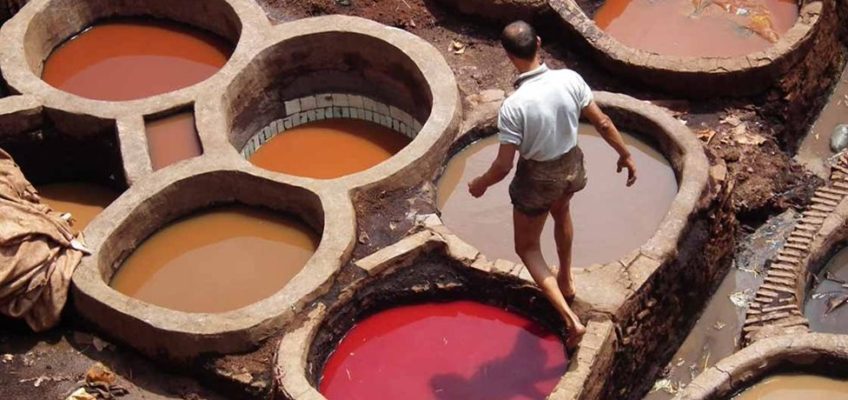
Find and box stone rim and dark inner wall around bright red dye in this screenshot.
[275,231,616,400]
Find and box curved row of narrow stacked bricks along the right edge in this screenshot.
[742,152,848,344]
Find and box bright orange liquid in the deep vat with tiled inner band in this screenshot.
[250,119,410,179]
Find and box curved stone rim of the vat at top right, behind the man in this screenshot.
[550,0,836,98]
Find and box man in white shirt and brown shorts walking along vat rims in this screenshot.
[468,21,636,351]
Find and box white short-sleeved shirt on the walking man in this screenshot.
[498,64,592,161]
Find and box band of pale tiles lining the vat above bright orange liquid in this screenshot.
[241,93,422,158]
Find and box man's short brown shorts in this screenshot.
[509,146,587,216]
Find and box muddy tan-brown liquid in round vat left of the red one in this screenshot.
[111,206,319,313]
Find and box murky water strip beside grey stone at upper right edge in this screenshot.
[795,66,848,178]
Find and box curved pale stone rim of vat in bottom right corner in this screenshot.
[674,333,848,400]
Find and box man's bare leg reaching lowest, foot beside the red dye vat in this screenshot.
[513,210,586,351]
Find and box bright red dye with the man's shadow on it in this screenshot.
[320,301,567,400]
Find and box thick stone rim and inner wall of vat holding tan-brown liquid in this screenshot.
[72,158,355,362]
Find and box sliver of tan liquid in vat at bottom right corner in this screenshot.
[733,374,848,400]
